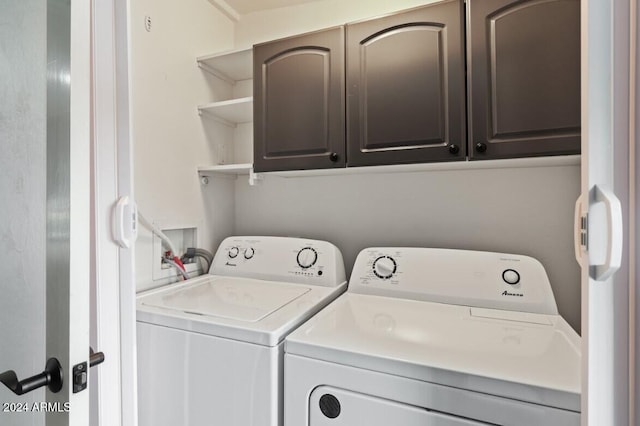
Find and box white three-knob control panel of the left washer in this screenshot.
[209,237,346,287]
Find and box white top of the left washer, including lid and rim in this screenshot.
[136,275,347,346]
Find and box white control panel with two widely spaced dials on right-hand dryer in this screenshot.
[348,247,558,315]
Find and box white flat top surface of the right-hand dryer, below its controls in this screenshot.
[285,293,581,411]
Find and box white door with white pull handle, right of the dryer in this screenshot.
[576,0,635,425]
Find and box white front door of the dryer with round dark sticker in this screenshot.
[309,386,488,426]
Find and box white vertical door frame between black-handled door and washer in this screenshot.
[90,0,137,426]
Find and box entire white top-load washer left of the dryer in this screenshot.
[137,237,346,426]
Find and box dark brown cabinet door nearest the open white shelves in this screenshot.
[253,27,346,172]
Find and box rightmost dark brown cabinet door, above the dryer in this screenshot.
[467,0,580,160]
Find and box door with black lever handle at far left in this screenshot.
[0,0,90,426]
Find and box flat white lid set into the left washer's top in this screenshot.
[142,277,310,322]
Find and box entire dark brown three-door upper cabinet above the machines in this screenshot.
[254,0,580,172]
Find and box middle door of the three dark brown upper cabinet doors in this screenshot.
[347,0,466,166]
